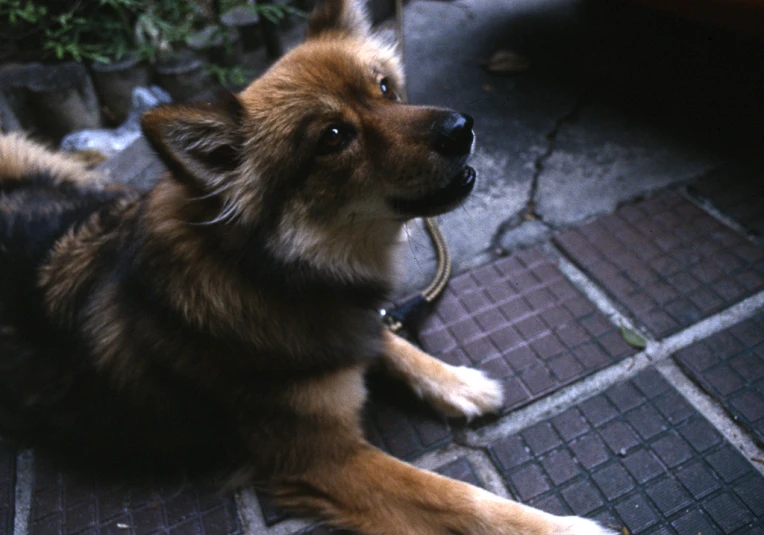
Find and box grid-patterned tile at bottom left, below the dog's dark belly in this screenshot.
[29,458,244,535]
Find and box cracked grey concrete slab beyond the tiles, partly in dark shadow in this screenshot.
[402,0,764,293]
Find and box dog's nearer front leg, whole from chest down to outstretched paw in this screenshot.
[274,356,609,535]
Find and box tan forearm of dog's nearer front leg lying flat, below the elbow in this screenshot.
[274,444,610,535]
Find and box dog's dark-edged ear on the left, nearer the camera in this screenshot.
[141,93,244,189]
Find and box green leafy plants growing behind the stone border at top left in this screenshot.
[0,0,304,65]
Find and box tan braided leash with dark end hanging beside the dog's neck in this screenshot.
[380,0,451,333]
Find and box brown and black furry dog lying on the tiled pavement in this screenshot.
[0,0,608,535]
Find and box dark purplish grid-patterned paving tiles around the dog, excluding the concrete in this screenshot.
[0,142,764,535]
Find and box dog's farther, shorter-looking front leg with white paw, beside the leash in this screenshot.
[382,332,503,420]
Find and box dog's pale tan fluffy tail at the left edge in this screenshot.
[0,133,102,188]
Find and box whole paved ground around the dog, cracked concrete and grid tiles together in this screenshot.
[0,0,764,535]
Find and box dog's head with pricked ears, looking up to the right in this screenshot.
[143,0,475,276]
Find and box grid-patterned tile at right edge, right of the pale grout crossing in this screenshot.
[674,312,764,447]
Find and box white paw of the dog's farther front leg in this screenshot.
[416,365,504,420]
